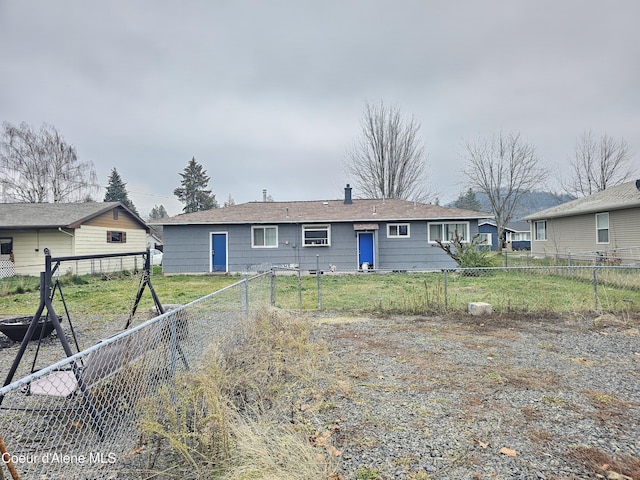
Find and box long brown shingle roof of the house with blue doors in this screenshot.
[159,199,492,225]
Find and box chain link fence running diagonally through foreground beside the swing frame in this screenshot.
[0,273,271,480]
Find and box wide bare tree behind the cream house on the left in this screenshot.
[0,122,97,203]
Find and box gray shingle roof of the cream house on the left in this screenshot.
[0,202,148,230]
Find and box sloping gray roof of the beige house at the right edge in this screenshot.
[522,180,640,220]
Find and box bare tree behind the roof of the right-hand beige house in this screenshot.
[562,131,634,197]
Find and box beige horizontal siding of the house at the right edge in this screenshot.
[531,208,640,256]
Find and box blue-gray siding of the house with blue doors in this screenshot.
[163,221,460,273]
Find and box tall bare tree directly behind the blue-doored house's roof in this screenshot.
[344,102,429,201]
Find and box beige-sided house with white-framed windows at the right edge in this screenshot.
[523,181,640,263]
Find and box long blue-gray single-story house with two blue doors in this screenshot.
[162,185,490,273]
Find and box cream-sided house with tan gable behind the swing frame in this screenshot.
[0,202,150,277]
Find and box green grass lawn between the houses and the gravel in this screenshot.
[0,266,640,315]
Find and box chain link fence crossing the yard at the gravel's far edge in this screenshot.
[272,265,640,314]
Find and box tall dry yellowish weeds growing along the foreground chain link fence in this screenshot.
[136,310,335,480]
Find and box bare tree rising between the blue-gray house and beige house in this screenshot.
[463,132,548,250]
